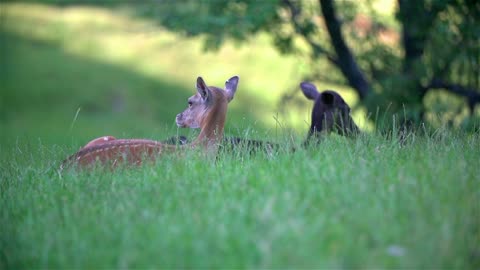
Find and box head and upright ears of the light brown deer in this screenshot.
[176,76,239,128]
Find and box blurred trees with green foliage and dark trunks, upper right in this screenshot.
[139,0,480,131]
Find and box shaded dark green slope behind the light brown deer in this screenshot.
[0,31,274,149]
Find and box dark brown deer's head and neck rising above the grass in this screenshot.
[300,82,359,145]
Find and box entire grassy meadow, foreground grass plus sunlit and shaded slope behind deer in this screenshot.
[0,3,480,269]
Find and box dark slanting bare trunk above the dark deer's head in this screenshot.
[320,0,370,100]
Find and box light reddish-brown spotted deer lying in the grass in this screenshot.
[60,76,239,170]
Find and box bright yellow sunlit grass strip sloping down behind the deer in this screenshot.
[3,4,316,130]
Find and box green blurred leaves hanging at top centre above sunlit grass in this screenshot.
[131,0,277,49]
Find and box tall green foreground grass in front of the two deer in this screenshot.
[0,132,480,269]
